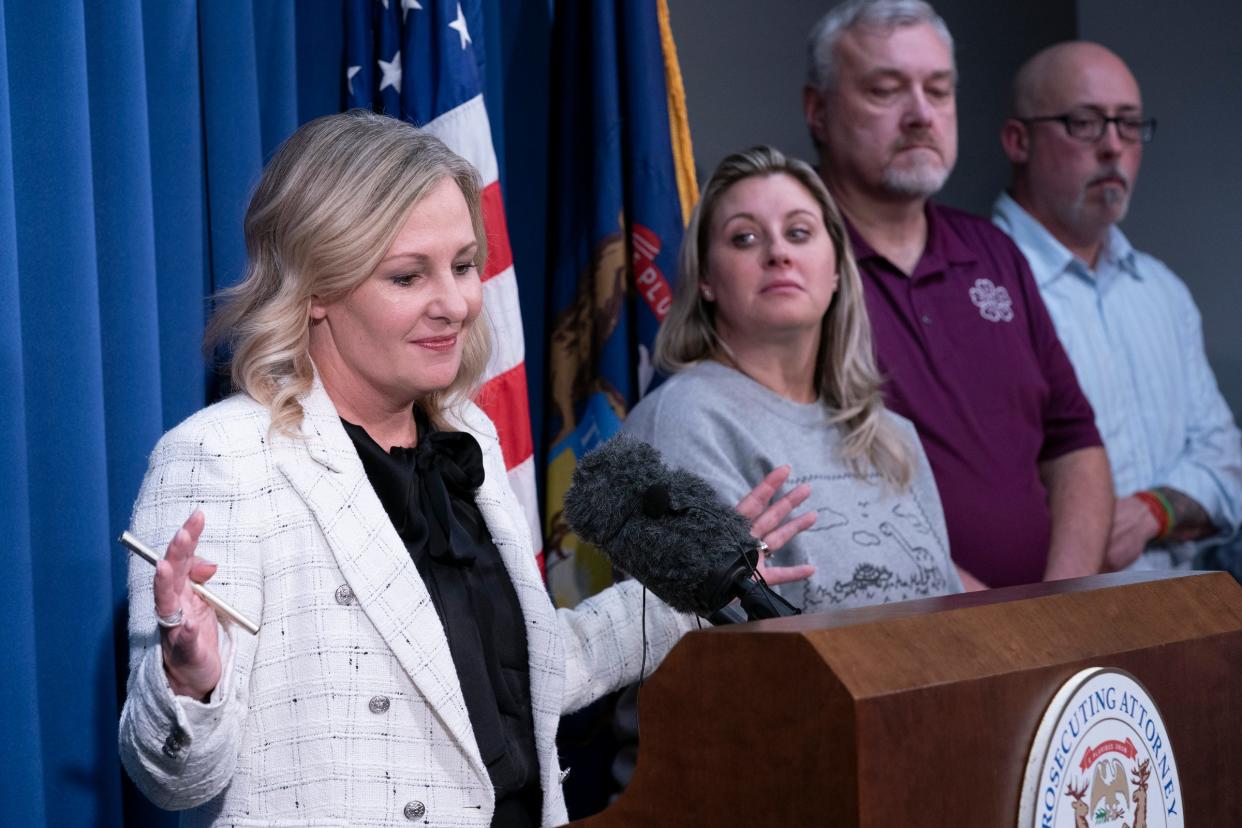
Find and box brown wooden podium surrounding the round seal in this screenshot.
[574,572,1242,828]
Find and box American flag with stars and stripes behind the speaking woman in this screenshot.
[344,0,543,566]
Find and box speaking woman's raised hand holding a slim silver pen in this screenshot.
[155,510,220,699]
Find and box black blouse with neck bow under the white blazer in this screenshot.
[342,407,543,827]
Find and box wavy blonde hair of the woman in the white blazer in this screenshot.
[204,109,491,434]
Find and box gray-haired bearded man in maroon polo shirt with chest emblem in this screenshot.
[804,0,1113,588]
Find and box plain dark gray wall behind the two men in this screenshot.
[668,0,1242,413]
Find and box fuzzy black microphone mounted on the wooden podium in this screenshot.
[565,434,799,621]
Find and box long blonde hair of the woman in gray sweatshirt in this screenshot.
[655,146,914,489]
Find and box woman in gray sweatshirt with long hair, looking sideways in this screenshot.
[625,146,963,612]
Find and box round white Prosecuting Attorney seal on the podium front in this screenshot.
[1017,667,1185,828]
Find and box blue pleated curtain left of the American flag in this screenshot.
[0,0,342,826]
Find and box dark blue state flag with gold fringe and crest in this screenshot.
[544,0,698,606]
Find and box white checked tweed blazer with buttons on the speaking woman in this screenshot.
[119,380,693,826]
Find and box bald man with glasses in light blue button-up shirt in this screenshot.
[992,42,1242,569]
